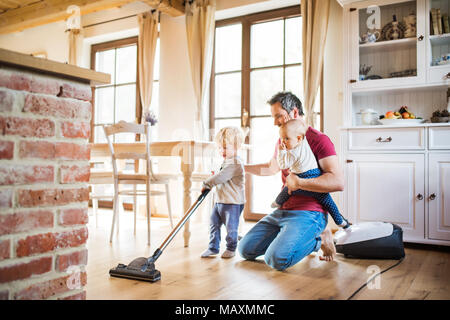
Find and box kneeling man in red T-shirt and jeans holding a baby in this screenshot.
[238,92,344,270]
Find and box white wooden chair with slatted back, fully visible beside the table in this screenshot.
[103,121,177,245]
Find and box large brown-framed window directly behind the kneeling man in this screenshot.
[210,6,322,219]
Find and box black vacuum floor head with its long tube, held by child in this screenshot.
[109,189,210,282]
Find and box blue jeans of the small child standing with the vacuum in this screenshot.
[209,203,244,253]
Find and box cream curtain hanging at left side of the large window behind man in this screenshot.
[186,0,216,138]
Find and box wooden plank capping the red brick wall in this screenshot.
[0,49,111,86]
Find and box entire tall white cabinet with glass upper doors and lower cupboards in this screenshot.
[339,0,450,245]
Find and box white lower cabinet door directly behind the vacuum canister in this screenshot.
[347,154,425,241]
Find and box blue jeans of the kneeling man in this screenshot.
[238,210,328,271]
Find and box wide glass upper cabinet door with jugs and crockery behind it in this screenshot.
[349,0,426,88]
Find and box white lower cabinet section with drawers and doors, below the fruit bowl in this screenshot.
[342,124,450,245]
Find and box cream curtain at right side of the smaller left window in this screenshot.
[138,11,159,120]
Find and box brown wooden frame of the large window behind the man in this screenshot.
[209,5,324,221]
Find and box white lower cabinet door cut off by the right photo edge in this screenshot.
[427,153,450,240]
